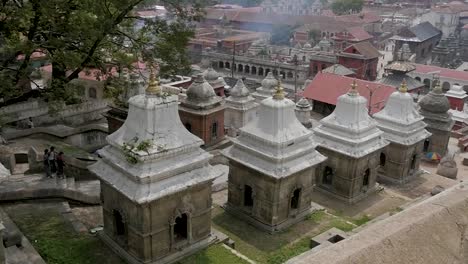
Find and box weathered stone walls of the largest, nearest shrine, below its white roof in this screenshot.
[101,182,212,263]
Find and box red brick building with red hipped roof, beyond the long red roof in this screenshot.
[337,42,381,81]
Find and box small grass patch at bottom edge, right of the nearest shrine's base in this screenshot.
[178,244,248,264]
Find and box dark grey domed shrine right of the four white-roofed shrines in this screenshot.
[419,81,455,155]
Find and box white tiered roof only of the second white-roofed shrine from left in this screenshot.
[222,83,326,178]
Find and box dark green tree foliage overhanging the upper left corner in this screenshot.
[0,0,209,104]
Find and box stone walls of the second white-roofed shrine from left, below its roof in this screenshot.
[228,160,315,231]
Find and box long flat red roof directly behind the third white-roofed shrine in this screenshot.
[303,72,396,113]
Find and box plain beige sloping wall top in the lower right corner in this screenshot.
[287,183,468,264]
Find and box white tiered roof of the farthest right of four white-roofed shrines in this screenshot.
[374,82,431,146]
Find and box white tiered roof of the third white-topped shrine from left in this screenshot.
[314,82,389,158]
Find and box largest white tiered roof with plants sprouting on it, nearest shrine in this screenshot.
[89,73,220,204]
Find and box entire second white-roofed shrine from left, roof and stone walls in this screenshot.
[222,84,326,232]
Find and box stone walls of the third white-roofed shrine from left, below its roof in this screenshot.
[317,147,381,203]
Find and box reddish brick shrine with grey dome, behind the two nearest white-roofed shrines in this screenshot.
[179,75,225,147]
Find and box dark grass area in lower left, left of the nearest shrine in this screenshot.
[8,204,124,264]
